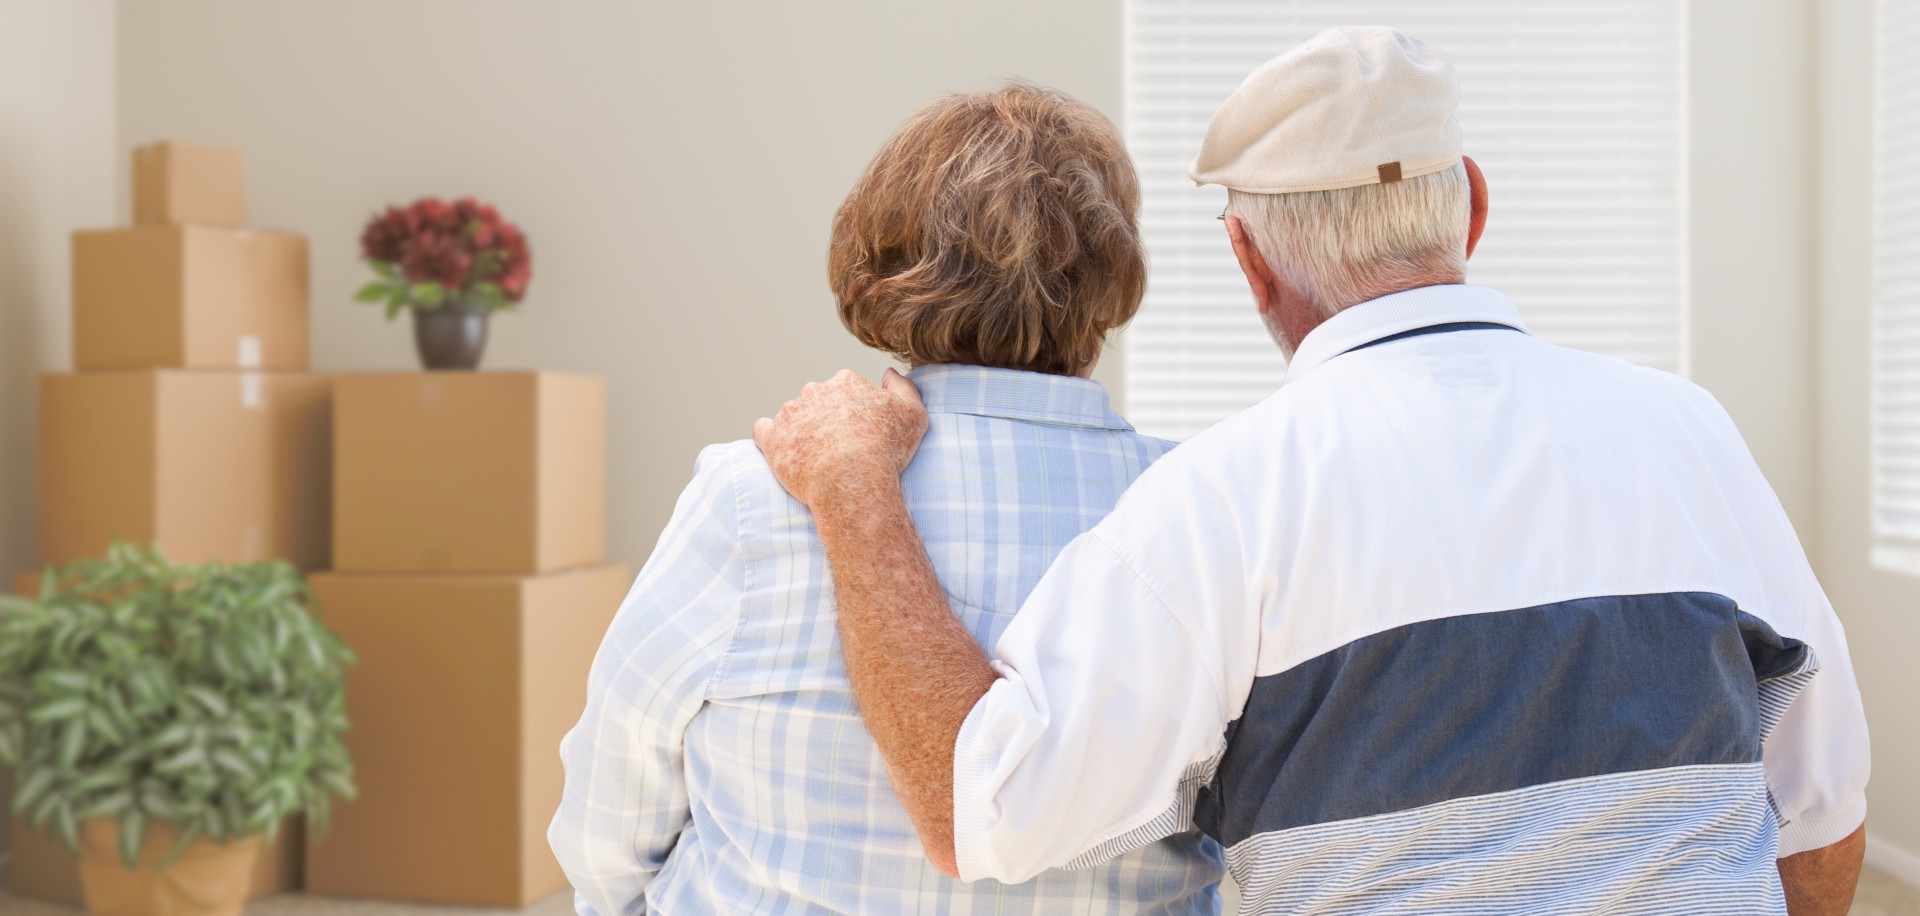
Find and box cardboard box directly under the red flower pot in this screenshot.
[334,373,607,574]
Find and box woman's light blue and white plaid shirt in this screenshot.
[547,365,1223,916]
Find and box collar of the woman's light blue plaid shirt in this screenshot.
[906,365,1133,430]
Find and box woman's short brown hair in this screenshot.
[828,84,1146,374]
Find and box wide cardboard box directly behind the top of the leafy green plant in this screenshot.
[40,371,332,568]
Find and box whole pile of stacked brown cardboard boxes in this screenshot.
[10,144,628,906]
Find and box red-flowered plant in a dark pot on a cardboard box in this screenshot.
[353,198,534,369]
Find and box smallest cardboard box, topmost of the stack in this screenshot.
[132,142,246,227]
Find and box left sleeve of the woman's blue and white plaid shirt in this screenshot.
[547,446,743,916]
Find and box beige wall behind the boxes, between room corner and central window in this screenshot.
[119,0,1121,563]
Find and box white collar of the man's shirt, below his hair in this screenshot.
[1286,284,1526,382]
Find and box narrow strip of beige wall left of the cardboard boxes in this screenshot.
[0,0,115,851]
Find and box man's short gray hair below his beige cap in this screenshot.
[1227,165,1469,317]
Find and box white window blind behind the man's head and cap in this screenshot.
[1125,0,1689,439]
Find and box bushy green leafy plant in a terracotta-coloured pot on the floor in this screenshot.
[0,543,353,916]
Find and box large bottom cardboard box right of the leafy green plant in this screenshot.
[307,566,628,906]
